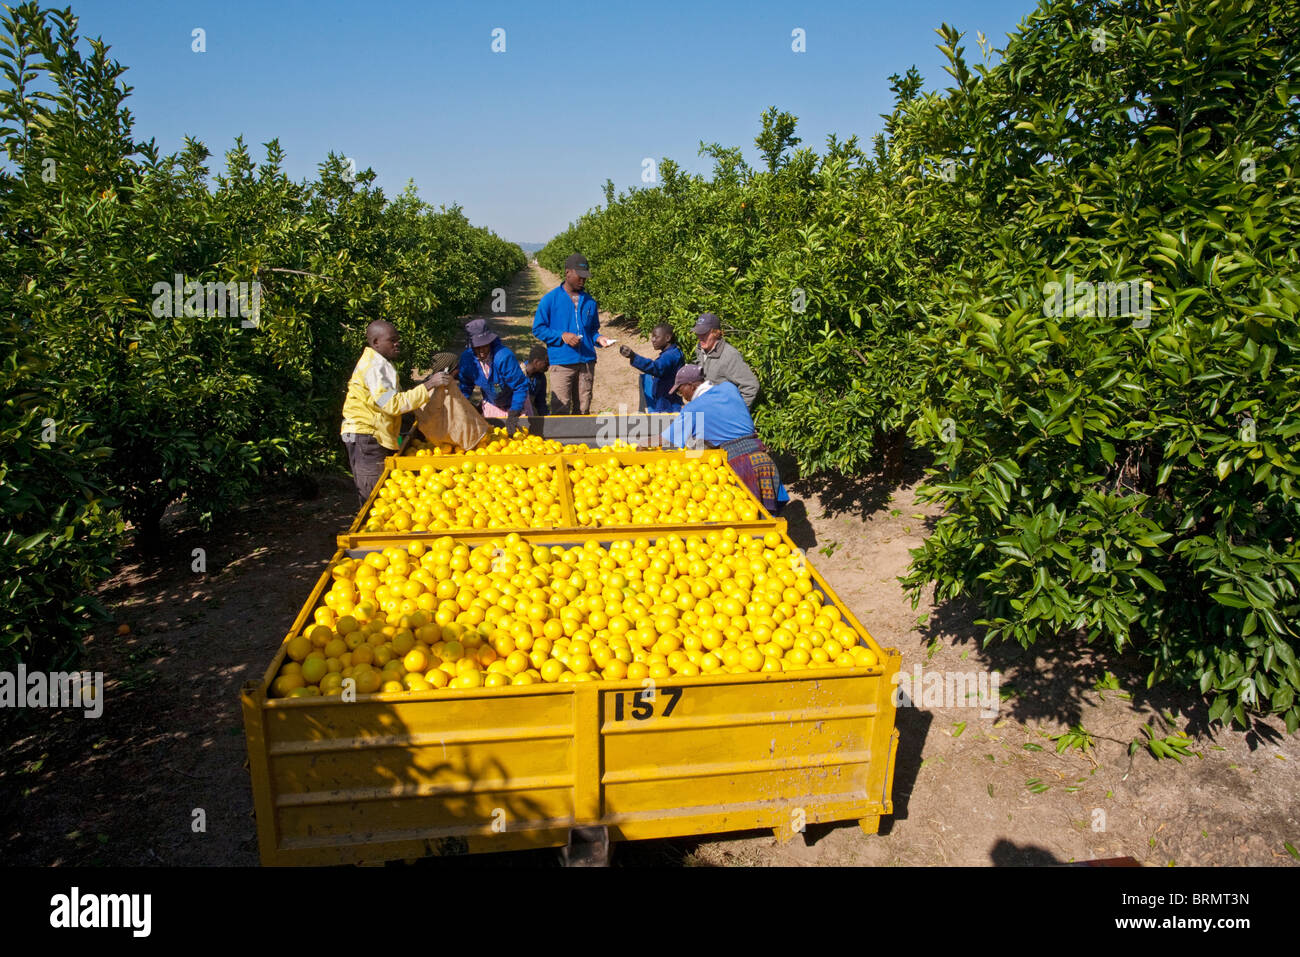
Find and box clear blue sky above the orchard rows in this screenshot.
[69,0,1035,242]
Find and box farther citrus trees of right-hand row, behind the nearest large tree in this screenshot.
[538,107,961,472]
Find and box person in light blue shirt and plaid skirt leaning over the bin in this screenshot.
[662,365,790,515]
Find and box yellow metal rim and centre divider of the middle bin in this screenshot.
[347,449,772,547]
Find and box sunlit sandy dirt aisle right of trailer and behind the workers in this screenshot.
[467,257,1300,866]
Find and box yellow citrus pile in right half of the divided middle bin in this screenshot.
[569,456,758,528]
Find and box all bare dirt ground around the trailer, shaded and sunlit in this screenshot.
[0,265,1300,866]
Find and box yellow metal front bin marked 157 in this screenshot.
[242,529,900,865]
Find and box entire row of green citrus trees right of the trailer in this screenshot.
[540,0,1300,731]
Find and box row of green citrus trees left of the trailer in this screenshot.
[0,3,525,665]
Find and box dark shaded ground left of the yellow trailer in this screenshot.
[0,476,356,866]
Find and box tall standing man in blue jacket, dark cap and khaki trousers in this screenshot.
[533,252,614,415]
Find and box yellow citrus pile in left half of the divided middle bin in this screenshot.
[364,462,564,532]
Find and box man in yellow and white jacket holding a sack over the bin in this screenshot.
[341,319,452,503]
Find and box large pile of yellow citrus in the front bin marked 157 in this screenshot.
[272,528,878,697]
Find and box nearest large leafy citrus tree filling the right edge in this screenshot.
[907,3,1300,731]
